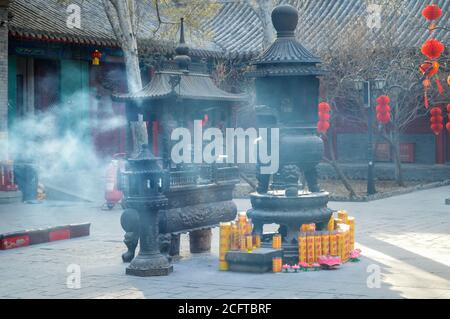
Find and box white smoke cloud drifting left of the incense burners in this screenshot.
[8,92,127,204]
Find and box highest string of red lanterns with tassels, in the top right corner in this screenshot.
[419,4,445,108]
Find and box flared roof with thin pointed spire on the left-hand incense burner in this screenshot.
[114,19,248,102]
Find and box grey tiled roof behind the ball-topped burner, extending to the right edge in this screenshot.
[208,0,450,55]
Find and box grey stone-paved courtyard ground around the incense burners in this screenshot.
[0,187,450,299]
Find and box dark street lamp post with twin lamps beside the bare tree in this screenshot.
[354,78,386,195]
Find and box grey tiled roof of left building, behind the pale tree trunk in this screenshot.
[9,0,222,56]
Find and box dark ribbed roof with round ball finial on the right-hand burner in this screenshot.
[248,5,324,77]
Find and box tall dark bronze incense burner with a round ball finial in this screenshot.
[248,5,331,264]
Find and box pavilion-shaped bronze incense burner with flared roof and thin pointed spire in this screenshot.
[115,19,247,276]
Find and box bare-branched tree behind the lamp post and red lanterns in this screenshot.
[322,12,448,186]
